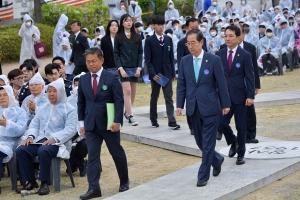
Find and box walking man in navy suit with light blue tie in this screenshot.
[176,29,231,187]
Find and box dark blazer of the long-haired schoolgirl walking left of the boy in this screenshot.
[114,35,143,68]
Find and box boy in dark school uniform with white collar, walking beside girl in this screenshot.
[144,16,180,130]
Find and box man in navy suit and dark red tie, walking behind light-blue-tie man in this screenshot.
[216,26,255,165]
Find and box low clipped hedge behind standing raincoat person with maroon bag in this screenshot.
[0,23,54,63]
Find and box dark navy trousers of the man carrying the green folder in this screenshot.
[86,124,129,190]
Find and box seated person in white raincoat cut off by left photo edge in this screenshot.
[0,85,27,180]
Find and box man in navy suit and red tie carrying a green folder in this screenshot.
[78,48,129,199]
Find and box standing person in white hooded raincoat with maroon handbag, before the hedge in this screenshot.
[19,14,43,66]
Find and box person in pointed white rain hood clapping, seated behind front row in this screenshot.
[21,72,49,128]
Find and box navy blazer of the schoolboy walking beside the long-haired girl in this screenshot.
[144,34,175,80]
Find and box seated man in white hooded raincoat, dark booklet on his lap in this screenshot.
[16,78,77,195]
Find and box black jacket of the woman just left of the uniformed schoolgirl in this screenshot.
[101,35,116,69]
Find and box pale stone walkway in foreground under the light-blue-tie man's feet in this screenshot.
[107,158,300,200]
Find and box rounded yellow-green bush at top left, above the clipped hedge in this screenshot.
[42,0,109,36]
